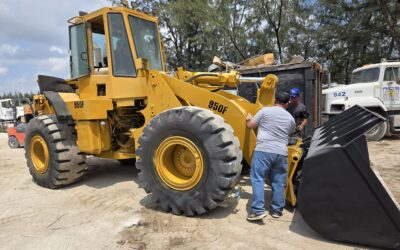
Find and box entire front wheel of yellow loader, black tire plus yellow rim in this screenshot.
[136,107,242,216]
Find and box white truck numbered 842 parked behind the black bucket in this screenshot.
[322,62,400,141]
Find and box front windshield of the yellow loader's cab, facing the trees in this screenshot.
[129,16,162,70]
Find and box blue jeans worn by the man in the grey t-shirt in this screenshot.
[250,151,287,214]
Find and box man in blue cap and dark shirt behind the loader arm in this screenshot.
[287,88,310,132]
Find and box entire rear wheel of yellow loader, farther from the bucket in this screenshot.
[25,115,86,189]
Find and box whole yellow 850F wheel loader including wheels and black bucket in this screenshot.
[25,4,400,248]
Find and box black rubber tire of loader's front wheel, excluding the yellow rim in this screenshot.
[136,107,242,216]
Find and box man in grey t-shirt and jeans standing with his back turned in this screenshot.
[246,92,296,221]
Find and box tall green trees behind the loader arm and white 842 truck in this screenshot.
[139,0,400,83]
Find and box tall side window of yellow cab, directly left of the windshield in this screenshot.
[108,13,136,76]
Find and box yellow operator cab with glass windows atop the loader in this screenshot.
[69,7,165,79]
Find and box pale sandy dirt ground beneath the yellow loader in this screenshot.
[0,134,400,249]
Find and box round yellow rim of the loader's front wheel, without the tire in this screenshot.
[153,136,204,191]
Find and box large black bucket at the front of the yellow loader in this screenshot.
[297,106,400,249]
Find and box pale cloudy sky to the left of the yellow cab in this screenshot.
[0,0,111,94]
